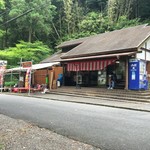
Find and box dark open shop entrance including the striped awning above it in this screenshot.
[64,58,125,88]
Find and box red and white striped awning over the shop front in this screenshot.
[67,58,116,71]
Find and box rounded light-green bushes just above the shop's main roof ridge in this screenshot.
[79,12,140,35]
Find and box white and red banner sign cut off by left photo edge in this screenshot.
[0,60,7,88]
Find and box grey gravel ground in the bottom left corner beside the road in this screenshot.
[0,114,100,150]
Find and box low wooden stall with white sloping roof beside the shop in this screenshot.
[5,62,60,88]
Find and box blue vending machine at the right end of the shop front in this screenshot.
[128,59,148,90]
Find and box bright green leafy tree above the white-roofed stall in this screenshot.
[0,41,52,67]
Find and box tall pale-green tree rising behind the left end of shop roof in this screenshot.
[53,0,84,41]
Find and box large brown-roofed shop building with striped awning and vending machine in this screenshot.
[57,25,150,90]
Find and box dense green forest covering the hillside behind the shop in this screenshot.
[0,0,150,65]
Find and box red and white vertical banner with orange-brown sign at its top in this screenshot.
[22,61,32,89]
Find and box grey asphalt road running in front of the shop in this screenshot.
[0,94,150,150]
